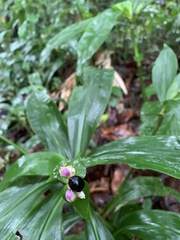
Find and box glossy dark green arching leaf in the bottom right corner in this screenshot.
[113,210,180,240]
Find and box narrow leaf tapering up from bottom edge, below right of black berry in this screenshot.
[86,209,114,240]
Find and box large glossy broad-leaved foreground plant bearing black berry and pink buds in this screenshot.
[0,43,180,240]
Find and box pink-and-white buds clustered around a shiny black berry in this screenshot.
[59,166,85,202]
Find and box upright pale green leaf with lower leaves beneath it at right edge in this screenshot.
[141,44,180,136]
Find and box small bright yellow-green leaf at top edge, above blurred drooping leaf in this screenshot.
[112,1,133,20]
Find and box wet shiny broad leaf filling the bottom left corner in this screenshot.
[0,182,51,239]
